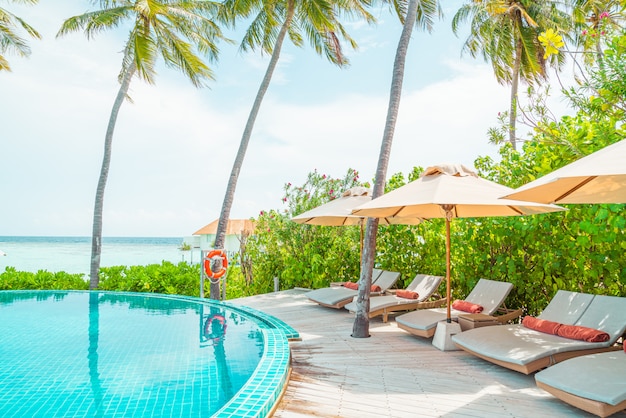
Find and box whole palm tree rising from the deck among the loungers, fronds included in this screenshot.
[352,0,442,338]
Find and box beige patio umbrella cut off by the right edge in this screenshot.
[504,140,626,203]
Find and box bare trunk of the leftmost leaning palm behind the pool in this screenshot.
[89,65,135,290]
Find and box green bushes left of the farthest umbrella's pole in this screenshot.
[241,169,361,294]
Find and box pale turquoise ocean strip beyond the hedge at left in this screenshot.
[0,236,200,275]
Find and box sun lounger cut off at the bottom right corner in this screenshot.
[535,351,626,417]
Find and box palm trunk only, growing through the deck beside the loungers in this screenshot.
[352,0,418,338]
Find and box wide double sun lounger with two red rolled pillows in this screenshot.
[452,290,626,374]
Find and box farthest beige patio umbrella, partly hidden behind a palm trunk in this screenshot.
[291,187,422,250]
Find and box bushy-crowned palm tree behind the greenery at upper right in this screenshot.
[452,0,571,149]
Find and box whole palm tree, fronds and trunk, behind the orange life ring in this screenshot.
[208,0,374,299]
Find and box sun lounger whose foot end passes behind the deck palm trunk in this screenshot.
[344,274,446,322]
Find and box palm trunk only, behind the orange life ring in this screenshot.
[208,0,295,299]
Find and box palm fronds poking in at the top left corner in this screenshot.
[0,0,41,71]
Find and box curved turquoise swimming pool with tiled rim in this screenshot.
[0,291,297,417]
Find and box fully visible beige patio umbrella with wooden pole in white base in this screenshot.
[352,165,565,322]
